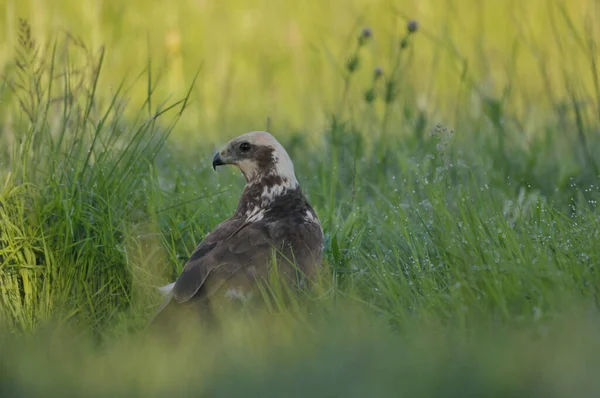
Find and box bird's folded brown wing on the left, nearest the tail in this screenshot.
[172,219,271,302]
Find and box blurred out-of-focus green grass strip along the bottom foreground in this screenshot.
[0,307,600,398]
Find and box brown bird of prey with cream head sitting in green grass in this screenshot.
[152,131,323,324]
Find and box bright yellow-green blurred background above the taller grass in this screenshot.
[0,0,600,140]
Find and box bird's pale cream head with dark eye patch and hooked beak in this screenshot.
[213,131,298,188]
